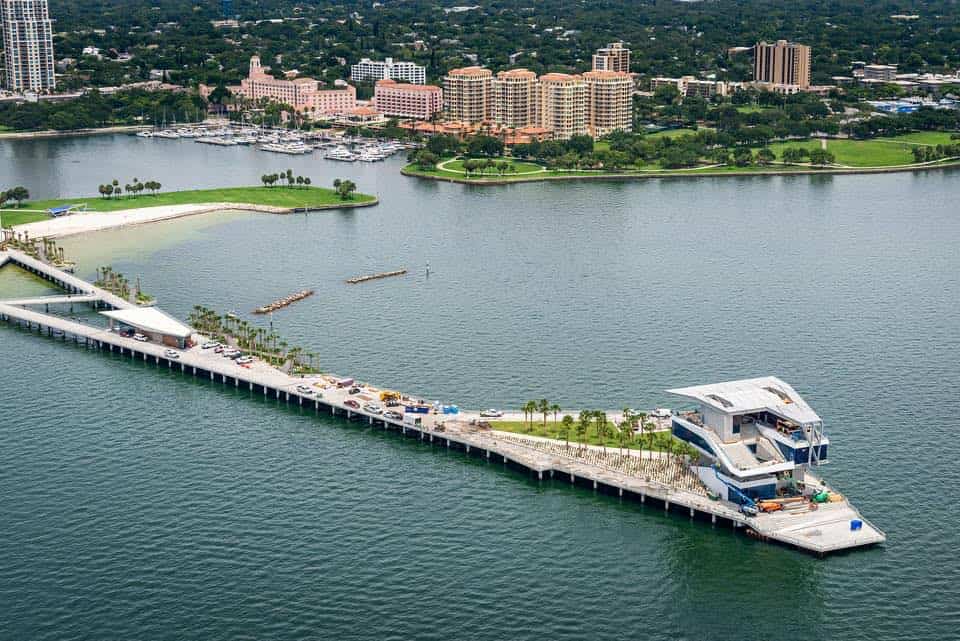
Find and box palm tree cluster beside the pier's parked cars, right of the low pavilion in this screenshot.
[189,305,320,374]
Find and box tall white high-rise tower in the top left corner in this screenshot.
[0,0,56,93]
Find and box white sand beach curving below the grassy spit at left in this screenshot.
[12,203,290,238]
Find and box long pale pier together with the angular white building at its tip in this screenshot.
[0,250,886,555]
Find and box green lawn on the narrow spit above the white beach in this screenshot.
[0,187,374,227]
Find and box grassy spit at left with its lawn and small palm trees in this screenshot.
[0,178,379,228]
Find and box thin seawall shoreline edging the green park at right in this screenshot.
[400,160,960,186]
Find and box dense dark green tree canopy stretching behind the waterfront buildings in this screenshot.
[51,0,960,93]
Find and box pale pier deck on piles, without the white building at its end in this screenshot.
[0,250,886,555]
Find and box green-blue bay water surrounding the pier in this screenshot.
[0,136,960,640]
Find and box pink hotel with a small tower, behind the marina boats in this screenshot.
[236,56,357,117]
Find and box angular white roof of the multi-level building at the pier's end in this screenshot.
[667,376,821,424]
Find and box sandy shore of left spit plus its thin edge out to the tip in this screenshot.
[10,196,380,238]
